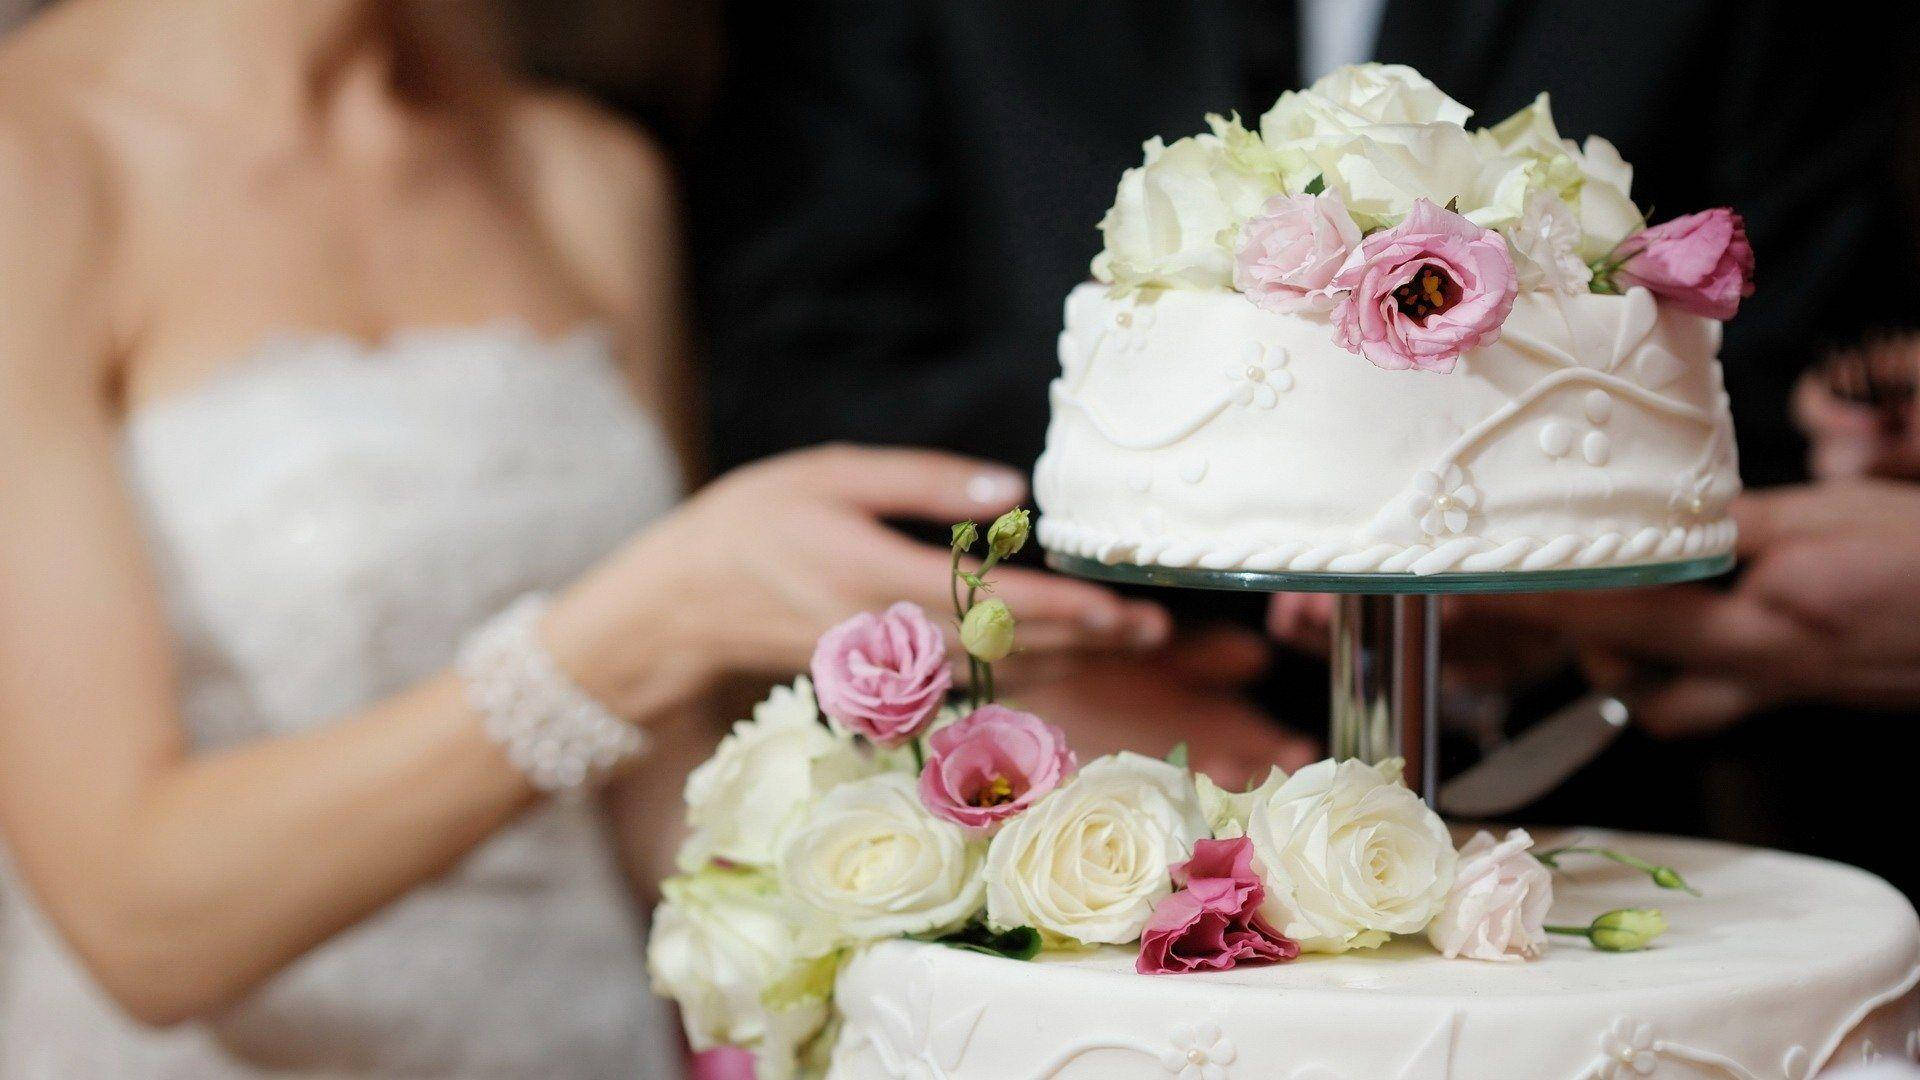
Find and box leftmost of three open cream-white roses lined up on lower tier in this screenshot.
[774,773,987,945]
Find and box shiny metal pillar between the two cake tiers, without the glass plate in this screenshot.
[1327,594,1440,798]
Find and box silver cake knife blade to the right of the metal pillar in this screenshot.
[1440,694,1632,819]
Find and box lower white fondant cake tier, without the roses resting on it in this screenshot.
[828,832,1920,1080]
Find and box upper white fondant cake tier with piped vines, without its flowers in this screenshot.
[1035,284,1740,575]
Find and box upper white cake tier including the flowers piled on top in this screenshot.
[1035,65,1751,575]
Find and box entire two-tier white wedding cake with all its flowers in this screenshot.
[649,65,1920,1080]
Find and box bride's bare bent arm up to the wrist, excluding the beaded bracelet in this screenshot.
[0,143,705,1022]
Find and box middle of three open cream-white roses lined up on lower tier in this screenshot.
[987,753,1206,945]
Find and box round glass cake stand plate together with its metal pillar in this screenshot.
[1046,552,1734,801]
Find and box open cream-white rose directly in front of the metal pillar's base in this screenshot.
[1246,761,1453,953]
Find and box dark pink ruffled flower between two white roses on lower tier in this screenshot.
[1133,836,1300,974]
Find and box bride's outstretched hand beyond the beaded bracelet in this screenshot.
[547,446,1169,707]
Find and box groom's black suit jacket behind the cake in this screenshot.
[687,0,1920,888]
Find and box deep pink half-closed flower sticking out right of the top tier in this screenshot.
[1613,206,1753,315]
